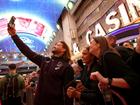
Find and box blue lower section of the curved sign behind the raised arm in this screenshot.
[0,33,46,53]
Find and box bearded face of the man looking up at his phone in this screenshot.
[52,42,65,54]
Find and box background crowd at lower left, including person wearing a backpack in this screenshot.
[0,63,39,105]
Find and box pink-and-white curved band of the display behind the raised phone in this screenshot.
[0,17,45,37]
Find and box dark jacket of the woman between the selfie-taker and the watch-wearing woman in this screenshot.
[80,59,104,105]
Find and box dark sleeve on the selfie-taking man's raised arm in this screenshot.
[12,35,46,67]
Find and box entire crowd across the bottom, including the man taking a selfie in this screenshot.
[0,19,140,105]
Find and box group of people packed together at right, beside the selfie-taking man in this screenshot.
[67,36,140,105]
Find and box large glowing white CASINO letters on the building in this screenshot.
[86,0,140,44]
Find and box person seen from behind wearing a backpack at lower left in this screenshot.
[0,64,25,105]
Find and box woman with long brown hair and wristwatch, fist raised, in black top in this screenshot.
[90,36,140,105]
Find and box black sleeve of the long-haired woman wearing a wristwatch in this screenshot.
[104,53,140,88]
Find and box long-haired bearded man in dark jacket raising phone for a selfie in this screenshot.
[8,24,74,105]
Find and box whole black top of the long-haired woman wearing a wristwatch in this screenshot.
[100,52,140,105]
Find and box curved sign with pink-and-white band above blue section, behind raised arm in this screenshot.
[0,17,47,52]
